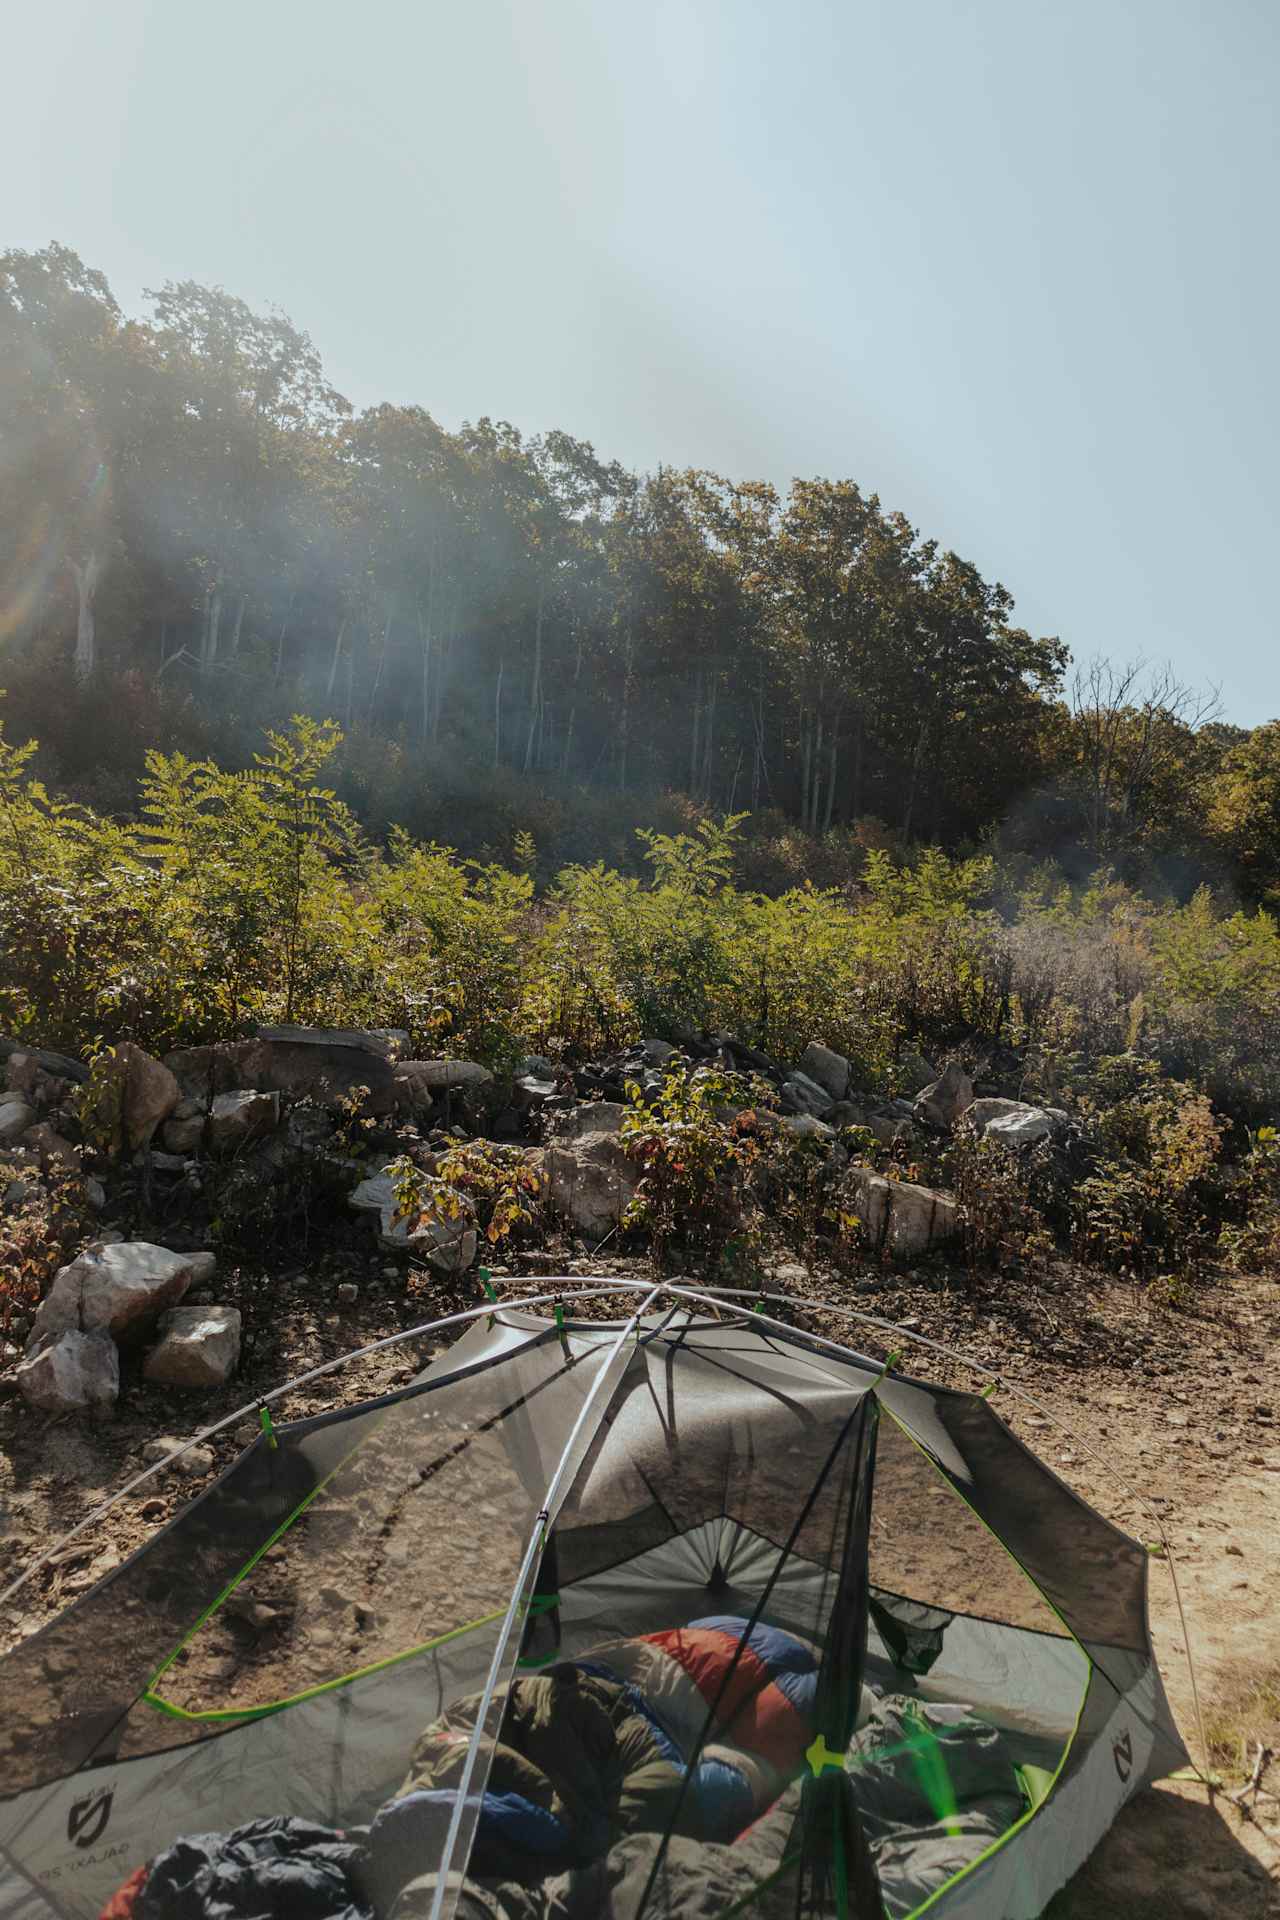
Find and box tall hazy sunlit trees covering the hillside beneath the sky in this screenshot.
[0,244,1280,904]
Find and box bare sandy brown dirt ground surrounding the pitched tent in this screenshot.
[0,1250,1280,1920]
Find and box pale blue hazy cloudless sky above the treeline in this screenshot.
[0,0,1280,724]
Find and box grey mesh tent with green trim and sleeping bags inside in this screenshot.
[0,1283,1186,1920]
